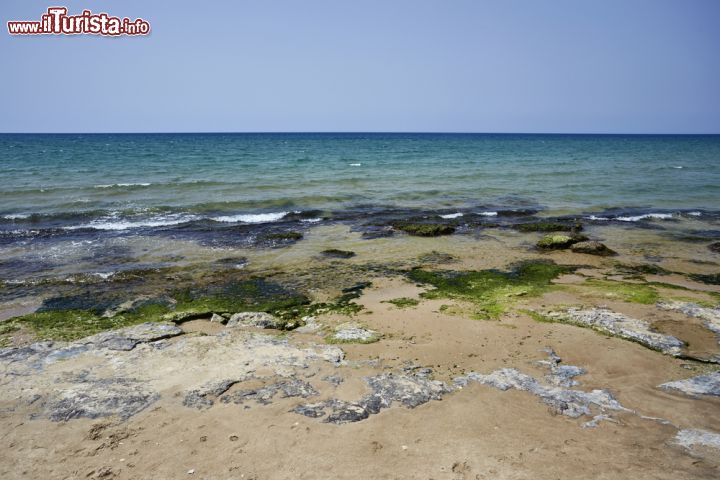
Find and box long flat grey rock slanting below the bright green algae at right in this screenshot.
[547,308,685,356]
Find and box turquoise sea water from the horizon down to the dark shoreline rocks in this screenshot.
[0,133,720,229]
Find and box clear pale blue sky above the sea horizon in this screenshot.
[0,0,720,133]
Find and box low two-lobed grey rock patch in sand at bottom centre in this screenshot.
[291,374,451,424]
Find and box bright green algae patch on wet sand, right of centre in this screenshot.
[408,260,574,319]
